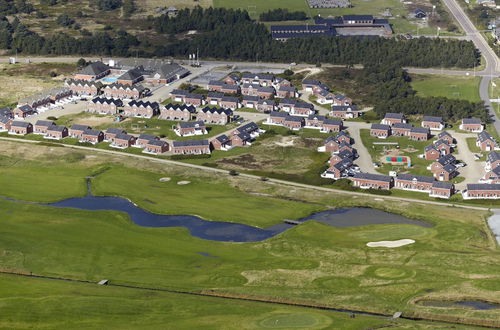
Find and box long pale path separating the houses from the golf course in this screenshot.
[0,137,489,211]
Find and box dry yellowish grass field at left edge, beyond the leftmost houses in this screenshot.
[0,63,76,108]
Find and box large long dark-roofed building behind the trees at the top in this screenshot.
[271,15,392,41]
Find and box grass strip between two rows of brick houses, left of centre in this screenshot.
[57,112,237,140]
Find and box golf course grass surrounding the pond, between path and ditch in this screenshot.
[0,143,500,322]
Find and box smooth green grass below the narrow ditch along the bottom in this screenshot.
[0,275,472,329]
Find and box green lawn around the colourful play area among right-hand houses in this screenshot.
[360,129,432,176]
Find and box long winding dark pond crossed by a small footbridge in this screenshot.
[45,195,431,242]
